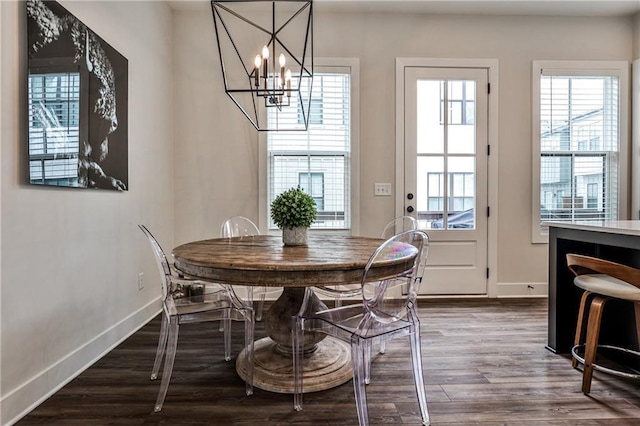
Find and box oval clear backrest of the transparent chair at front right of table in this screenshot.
[362,230,429,323]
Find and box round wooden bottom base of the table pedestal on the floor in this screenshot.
[236,337,353,394]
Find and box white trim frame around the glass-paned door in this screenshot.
[394,58,500,297]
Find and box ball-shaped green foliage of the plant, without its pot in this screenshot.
[271,185,318,229]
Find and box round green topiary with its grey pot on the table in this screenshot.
[271,185,318,246]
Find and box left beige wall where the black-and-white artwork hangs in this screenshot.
[0,1,174,424]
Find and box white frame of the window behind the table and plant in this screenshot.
[258,58,360,235]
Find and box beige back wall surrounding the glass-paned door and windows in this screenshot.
[174,9,633,290]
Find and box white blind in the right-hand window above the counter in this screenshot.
[539,69,620,226]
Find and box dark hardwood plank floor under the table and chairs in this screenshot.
[17,299,640,426]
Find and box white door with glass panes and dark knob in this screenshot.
[405,67,488,294]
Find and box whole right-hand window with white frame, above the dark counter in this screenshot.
[533,62,628,242]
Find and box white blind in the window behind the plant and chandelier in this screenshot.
[267,71,351,229]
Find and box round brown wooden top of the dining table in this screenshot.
[173,234,417,287]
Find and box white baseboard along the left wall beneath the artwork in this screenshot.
[0,297,161,426]
